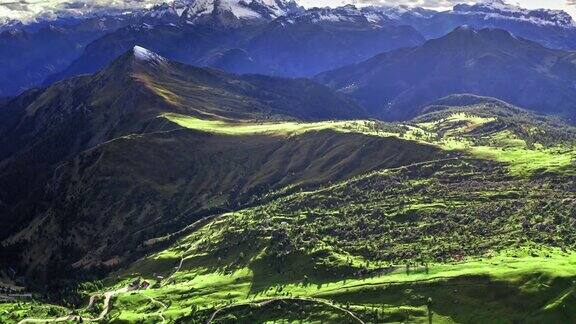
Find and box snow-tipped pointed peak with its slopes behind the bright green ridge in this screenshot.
[0,46,365,176]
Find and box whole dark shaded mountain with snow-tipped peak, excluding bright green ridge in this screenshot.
[0,47,420,278]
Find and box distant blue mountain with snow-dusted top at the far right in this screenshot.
[384,0,576,50]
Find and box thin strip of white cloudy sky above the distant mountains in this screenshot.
[0,0,576,22]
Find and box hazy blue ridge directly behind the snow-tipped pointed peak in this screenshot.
[42,3,424,83]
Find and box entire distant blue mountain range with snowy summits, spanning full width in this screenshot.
[0,0,576,96]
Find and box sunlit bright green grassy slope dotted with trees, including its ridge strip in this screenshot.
[5,105,576,323]
